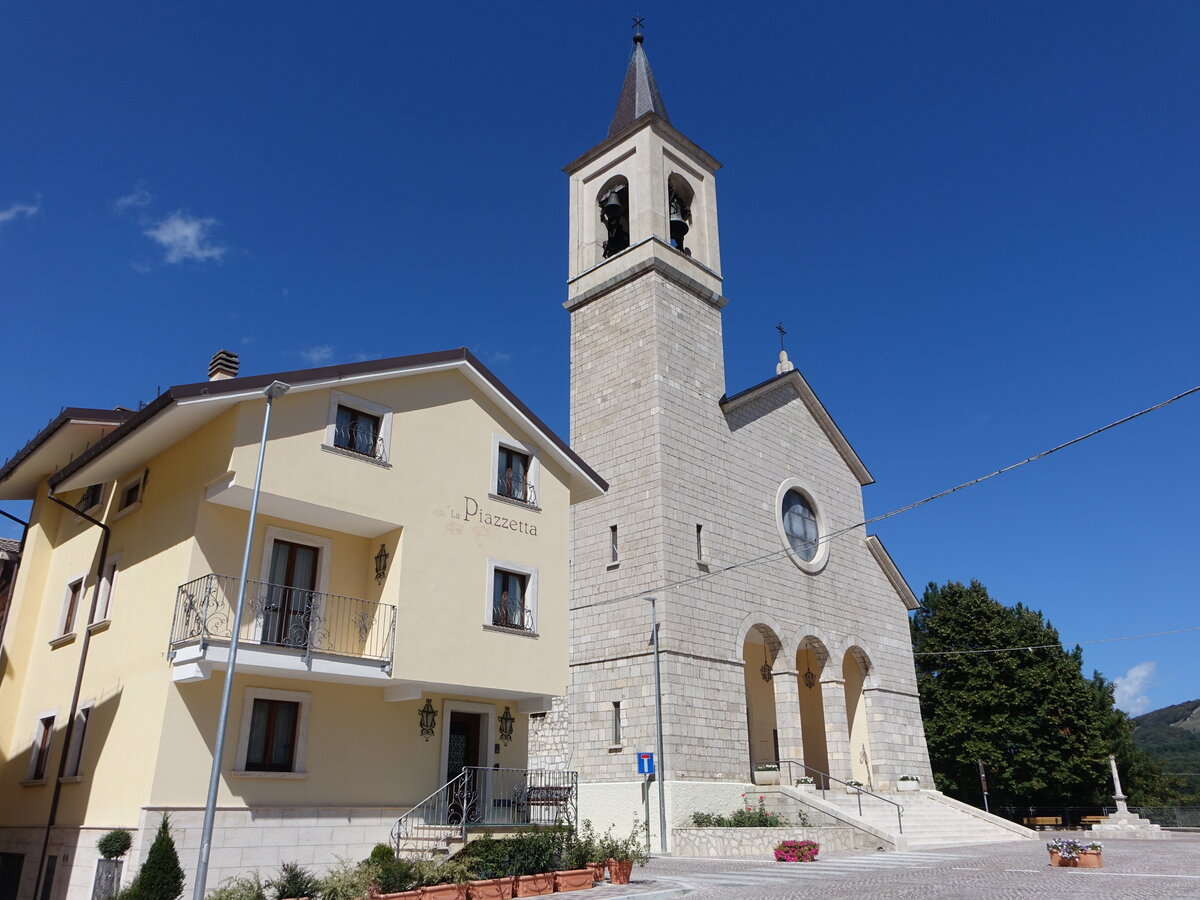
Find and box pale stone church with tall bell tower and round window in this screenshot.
[530,28,960,834]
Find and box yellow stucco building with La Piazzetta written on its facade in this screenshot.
[0,349,606,900]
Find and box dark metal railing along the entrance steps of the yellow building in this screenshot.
[391,766,580,856]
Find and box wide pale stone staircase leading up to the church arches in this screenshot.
[758,787,1037,850]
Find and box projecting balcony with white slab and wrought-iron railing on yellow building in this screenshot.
[170,575,396,684]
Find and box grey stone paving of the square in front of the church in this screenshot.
[586,832,1200,900]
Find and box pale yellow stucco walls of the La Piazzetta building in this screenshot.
[0,372,580,826]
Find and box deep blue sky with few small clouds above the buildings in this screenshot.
[0,0,1200,712]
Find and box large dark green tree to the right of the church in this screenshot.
[912,581,1120,805]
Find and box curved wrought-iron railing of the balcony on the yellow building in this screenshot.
[170,575,396,667]
